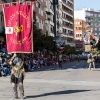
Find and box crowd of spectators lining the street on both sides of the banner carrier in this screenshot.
[0,41,86,76]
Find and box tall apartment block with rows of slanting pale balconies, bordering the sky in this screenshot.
[57,0,75,46]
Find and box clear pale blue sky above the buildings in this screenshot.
[74,0,100,11]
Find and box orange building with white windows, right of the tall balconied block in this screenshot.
[74,19,86,51]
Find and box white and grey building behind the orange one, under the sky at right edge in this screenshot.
[74,8,100,37]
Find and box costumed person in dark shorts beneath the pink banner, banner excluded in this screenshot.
[9,53,25,99]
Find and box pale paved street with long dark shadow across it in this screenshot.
[0,61,100,100]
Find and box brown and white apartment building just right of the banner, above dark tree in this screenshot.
[27,0,54,37]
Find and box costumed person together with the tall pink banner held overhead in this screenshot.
[2,2,35,98]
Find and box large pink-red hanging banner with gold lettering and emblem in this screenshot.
[3,3,33,53]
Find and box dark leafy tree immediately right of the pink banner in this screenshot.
[33,20,54,51]
